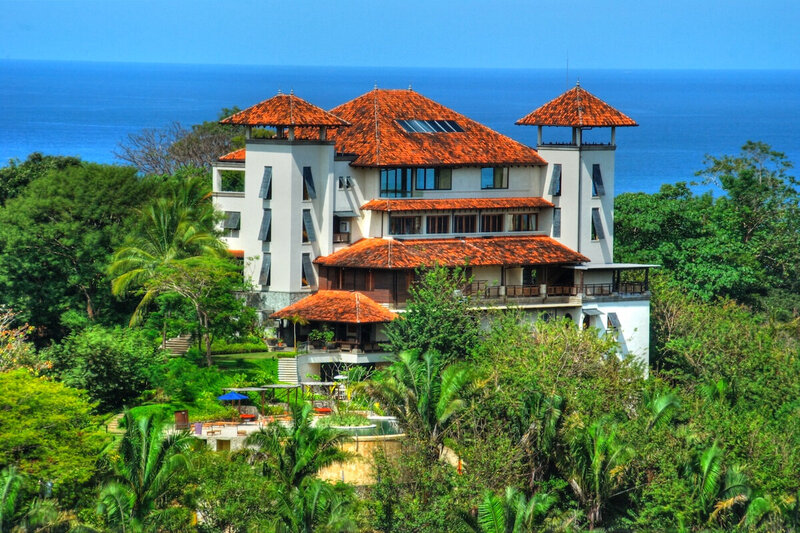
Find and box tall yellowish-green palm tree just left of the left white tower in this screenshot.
[108,178,225,325]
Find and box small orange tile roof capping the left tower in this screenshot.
[220,94,347,128]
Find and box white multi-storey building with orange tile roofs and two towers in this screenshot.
[214,86,653,374]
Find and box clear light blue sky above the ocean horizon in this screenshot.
[0,0,800,69]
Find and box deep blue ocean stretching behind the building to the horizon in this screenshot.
[0,60,800,194]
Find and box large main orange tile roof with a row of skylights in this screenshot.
[331,89,545,167]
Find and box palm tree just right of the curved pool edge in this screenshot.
[366,351,473,458]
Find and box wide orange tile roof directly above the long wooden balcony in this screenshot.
[314,235,589,269]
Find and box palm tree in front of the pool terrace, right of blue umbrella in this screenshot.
[245,404,350,490]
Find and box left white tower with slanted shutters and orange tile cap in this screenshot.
[214,93,348,309]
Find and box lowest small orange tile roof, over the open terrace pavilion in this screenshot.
[270,291,397,324]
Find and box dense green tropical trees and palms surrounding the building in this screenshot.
[0,135,800,532]
